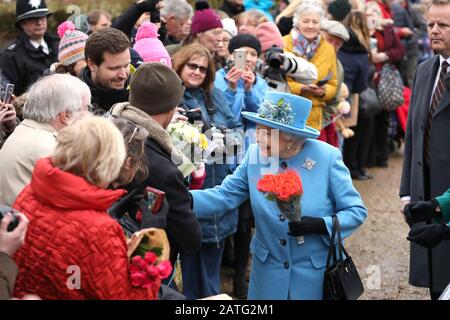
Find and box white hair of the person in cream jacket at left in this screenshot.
[22,74,91,123]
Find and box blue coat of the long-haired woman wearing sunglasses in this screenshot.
[183,88,241,243]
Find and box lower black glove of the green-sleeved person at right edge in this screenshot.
[407,223,450,248]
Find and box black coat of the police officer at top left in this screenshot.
[0,32,59,96]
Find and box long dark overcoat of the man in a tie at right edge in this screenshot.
[400,55,450,291]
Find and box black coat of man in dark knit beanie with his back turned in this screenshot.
[135,138,202,263]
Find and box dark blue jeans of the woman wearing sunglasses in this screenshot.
[181,240,225,300]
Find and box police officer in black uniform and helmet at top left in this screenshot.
[0,0,59,96]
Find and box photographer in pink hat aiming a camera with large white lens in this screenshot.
[256,22,318,93]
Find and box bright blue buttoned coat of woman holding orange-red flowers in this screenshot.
[192,139,367,300]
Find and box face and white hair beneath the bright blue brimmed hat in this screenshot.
[256,124,303,158]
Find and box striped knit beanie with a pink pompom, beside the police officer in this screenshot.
[58,21,88,66]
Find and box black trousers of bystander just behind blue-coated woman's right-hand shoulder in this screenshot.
[343,117,374,175]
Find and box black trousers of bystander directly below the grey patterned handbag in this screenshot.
[367,110,389,167]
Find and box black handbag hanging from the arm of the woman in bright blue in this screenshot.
[323,215,364,300]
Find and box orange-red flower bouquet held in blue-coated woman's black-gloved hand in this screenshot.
[257,170,304,244]
